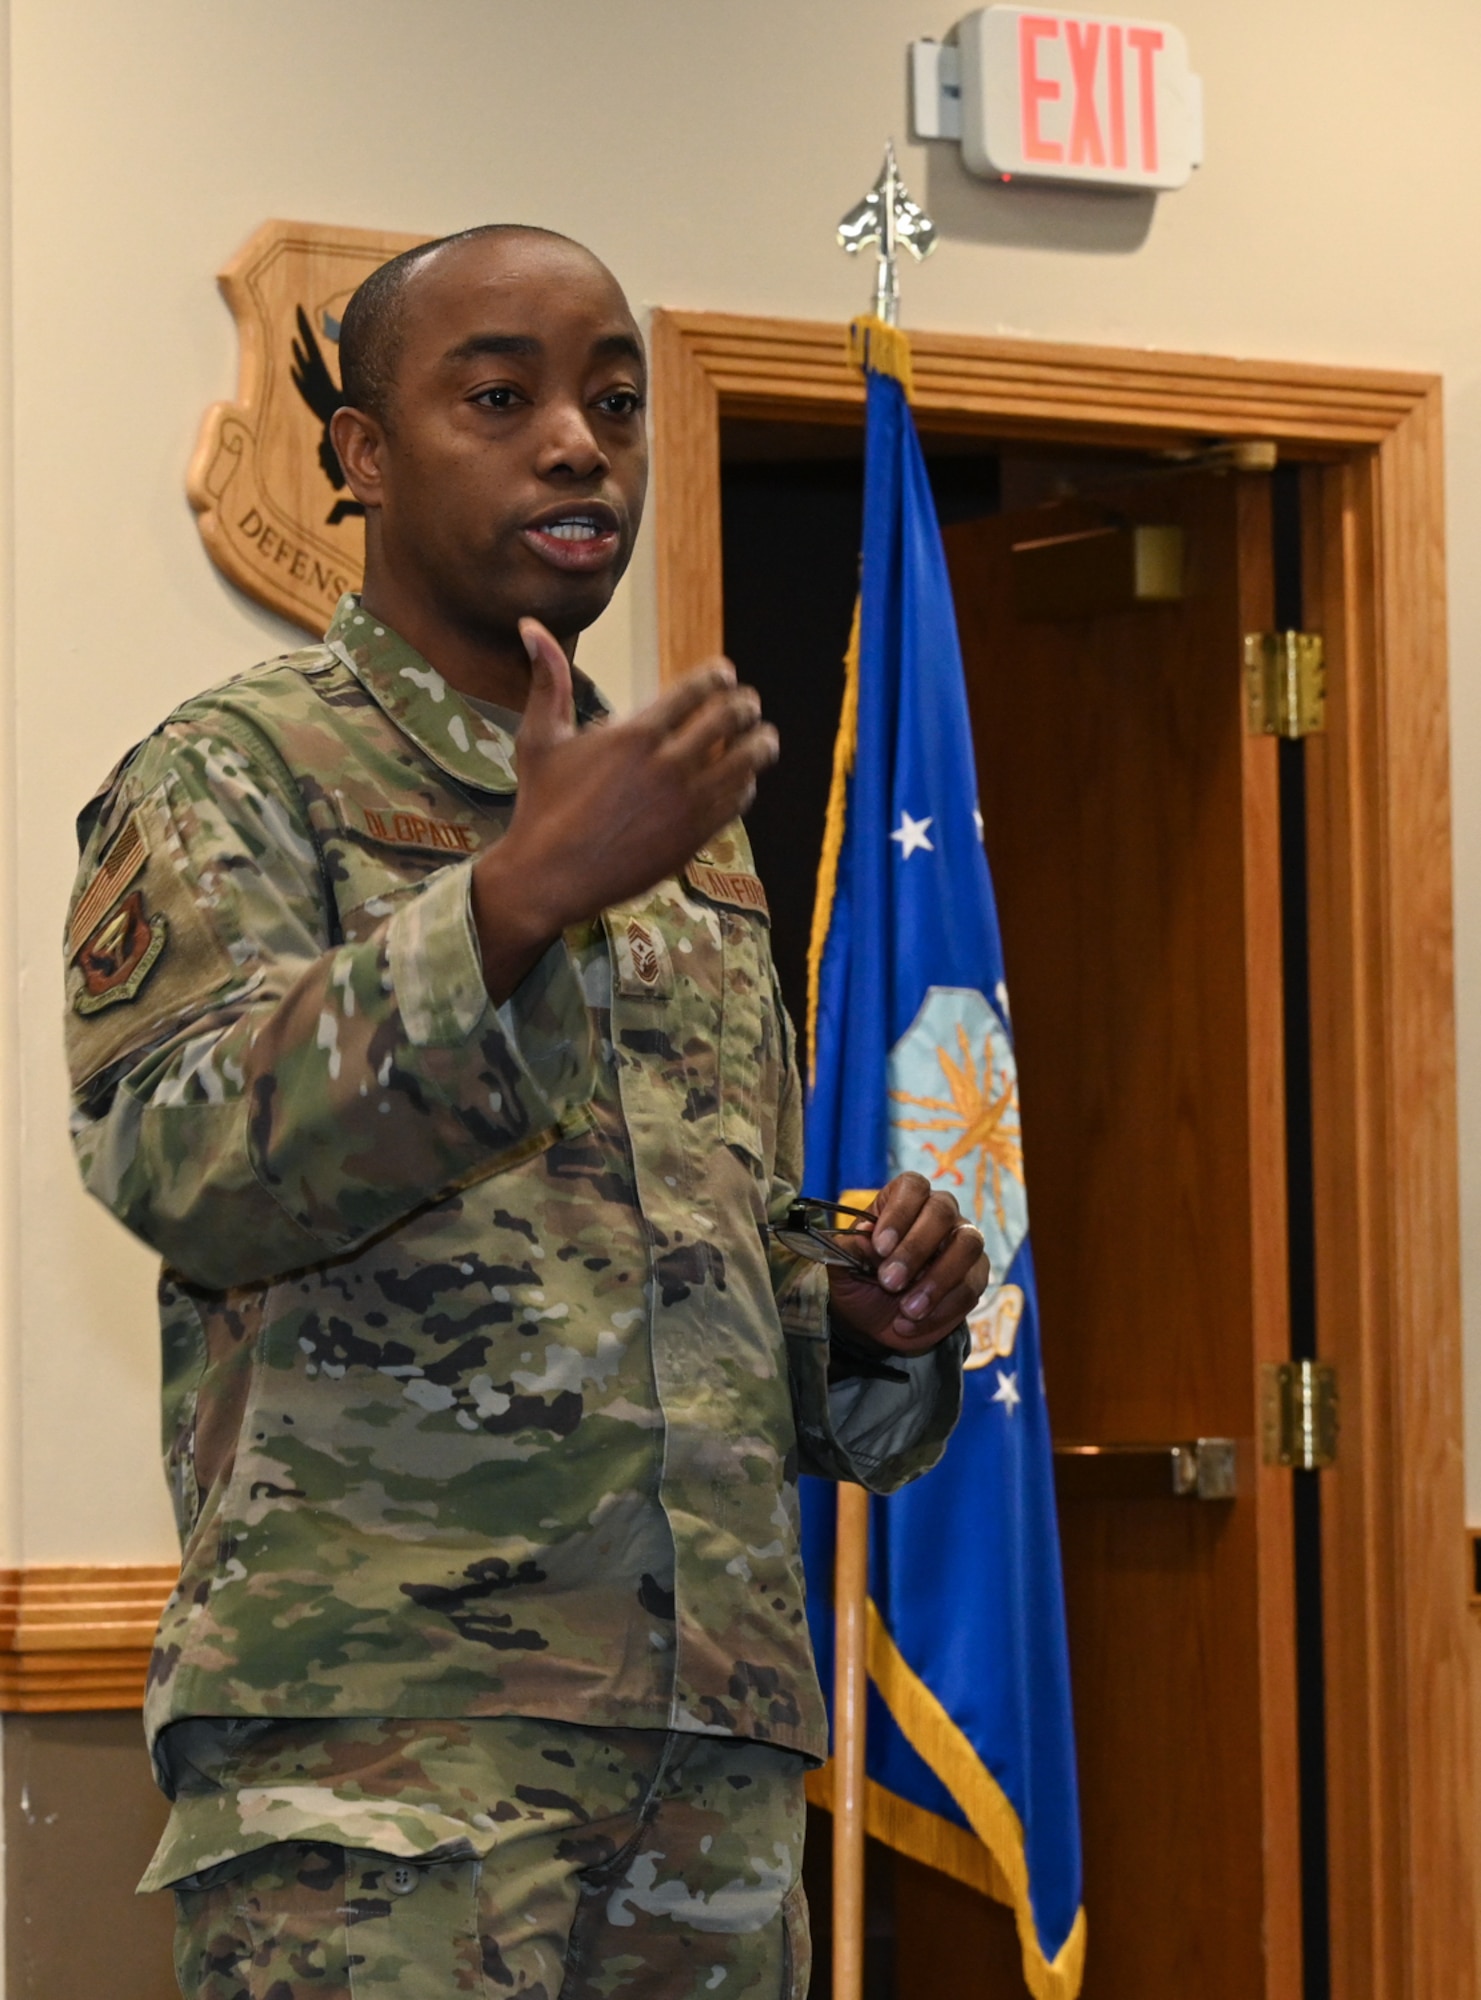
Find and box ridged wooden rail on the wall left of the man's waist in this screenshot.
[0,1562,176,1714]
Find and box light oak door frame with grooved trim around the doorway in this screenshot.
[652,312,1475,2000]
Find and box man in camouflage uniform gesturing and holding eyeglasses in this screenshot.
[68,230,987,2000]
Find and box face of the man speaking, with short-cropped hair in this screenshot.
[356,234,648,640]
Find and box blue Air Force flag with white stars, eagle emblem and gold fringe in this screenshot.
[805,328,1085,2000]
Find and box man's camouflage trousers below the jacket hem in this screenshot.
[176,1722,811,2000]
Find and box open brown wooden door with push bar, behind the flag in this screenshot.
[897,474,1301,2000]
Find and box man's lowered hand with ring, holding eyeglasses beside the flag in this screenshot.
[829,1174,993,1354]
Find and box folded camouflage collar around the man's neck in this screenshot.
[324,592,608,792]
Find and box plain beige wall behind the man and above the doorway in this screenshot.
[0,0,1481,1562]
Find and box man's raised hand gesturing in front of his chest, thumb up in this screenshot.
[472,618,779,1000]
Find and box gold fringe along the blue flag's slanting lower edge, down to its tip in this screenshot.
[865,1598,1085,2000]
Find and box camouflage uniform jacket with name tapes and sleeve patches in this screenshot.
[68,600,961,1782]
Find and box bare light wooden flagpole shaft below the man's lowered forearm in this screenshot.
[833,1484,869,2000]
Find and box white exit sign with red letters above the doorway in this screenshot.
[959,6,1203,188]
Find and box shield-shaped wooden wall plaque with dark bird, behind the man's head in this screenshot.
[186,222,426,638]
